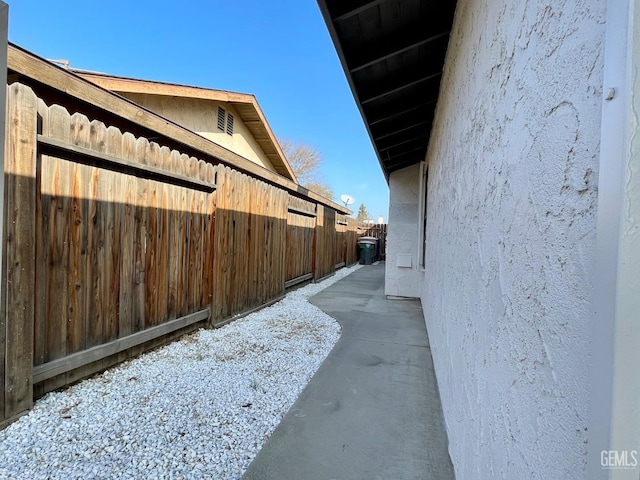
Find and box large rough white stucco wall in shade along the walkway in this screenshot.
[421,0,605,480]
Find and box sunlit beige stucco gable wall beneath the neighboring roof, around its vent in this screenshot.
[120,93,275,172]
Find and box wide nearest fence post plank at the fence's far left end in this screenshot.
[3,84,38,418]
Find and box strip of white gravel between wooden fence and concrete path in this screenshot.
[0,266,359,479]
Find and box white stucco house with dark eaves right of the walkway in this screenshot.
[318,0,640,480]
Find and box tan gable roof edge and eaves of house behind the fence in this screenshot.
[71,69,297,182]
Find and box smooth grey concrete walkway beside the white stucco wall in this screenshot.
[243,263,454,480]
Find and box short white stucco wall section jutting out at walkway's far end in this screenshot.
[384,165,420,297]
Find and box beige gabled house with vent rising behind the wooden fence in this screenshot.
[73,70,296,181]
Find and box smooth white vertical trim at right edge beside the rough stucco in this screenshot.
[587,0,640,480]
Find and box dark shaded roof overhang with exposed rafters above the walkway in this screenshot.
[317,0,456,180]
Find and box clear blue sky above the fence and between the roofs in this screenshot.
[5,0,389,221]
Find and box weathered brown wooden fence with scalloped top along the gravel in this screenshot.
[0,83,358,427]
